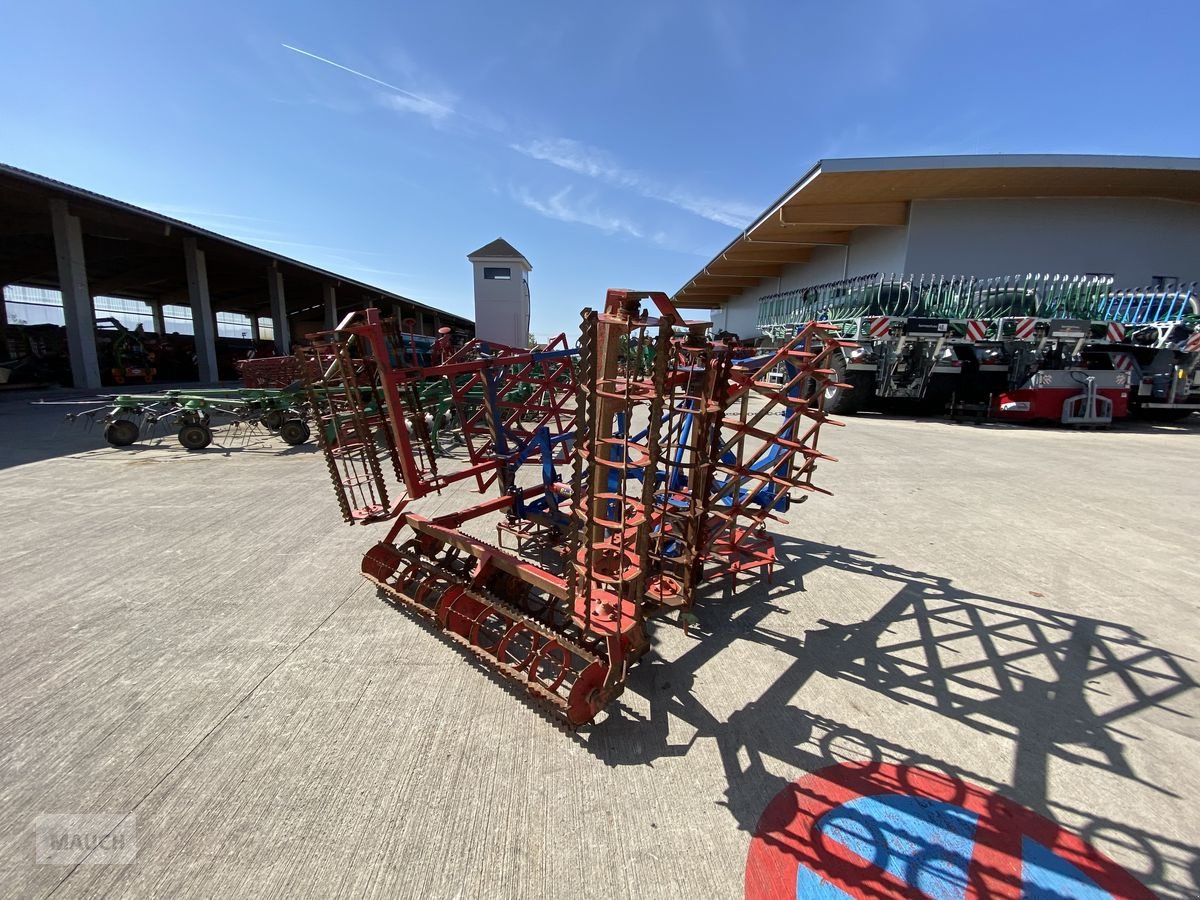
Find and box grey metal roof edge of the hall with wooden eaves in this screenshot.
[676,154,1200,300]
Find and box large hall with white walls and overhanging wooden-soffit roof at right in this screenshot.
[674,156,1200,338]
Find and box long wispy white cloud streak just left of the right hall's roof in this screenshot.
[509,138,758,228]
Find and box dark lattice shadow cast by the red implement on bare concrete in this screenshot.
[586,536,1200,898]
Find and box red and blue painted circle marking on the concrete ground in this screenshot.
[745,762,1154,900]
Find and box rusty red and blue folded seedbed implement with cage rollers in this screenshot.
[301,290,847,727]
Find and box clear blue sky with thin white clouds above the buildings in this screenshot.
[0,0,1200,336]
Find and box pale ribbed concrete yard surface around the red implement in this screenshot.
[0,397,1200,898]
